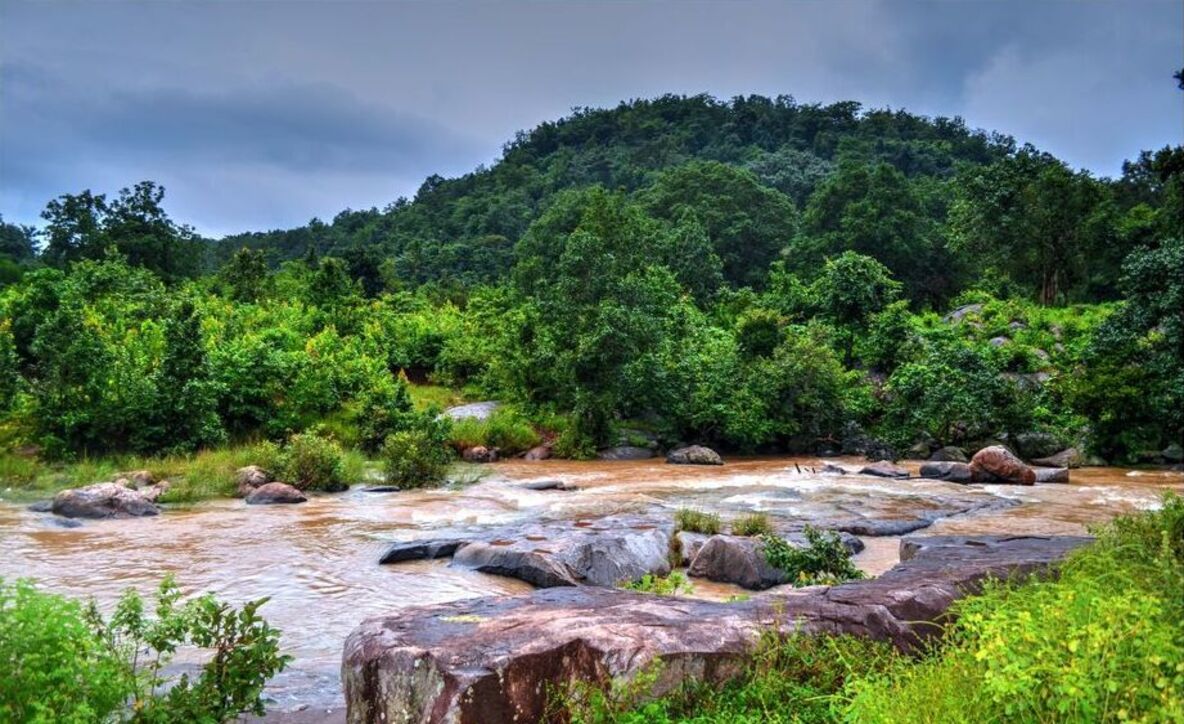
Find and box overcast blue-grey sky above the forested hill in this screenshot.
[0,0,1184,236]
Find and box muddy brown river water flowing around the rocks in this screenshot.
[0,457,1184,720]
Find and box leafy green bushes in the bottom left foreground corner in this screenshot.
[0,578,288,723]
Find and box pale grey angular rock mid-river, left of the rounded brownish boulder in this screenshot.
[452,515,674,588]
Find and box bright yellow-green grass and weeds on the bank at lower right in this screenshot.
[573,493,1184,724]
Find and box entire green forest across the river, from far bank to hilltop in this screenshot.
[0,91,1184,464]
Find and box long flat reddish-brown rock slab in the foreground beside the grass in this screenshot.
[341,537,1089,724]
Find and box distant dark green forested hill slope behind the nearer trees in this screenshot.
[217,96,1016,297]
